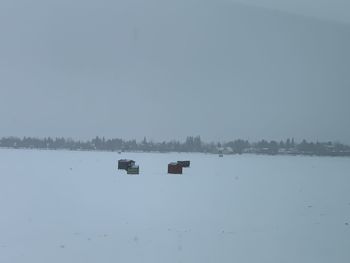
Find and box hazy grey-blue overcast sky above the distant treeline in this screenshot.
[0,0,350,143]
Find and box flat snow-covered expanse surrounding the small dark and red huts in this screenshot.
[0,149,350,263]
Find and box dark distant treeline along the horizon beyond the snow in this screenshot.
[0,136,350,156]
